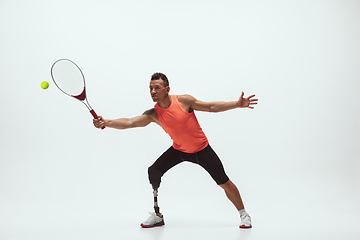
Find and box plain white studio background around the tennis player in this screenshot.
[0,0,360,240]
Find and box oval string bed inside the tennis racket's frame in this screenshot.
[52,60,85,96]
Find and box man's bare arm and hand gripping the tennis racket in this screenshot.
[93,110,155,129]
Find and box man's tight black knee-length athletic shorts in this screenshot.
[150,145,229,185]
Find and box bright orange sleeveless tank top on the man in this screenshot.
[155,95,209,153]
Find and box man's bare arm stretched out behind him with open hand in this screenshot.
[182,92,258,112]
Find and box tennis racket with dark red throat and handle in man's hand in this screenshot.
[51,59,105,129]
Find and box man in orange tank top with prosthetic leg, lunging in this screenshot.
[93,73,258,228]
